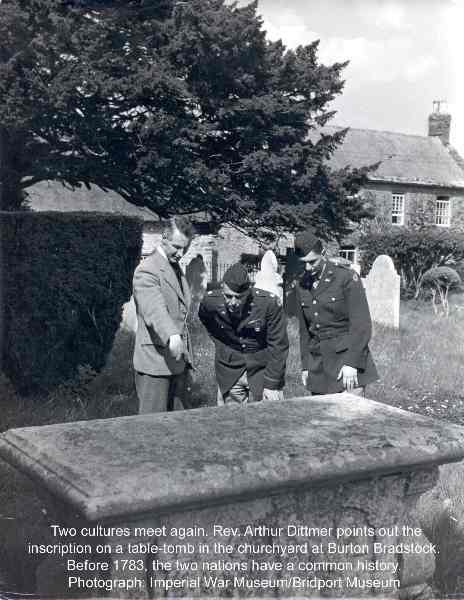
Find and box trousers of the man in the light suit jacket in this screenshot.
[135,370,189,415]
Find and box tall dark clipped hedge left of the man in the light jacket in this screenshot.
[0,212,143,392]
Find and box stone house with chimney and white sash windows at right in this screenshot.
[324,102,464,262]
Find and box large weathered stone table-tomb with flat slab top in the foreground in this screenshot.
[0,394,464,598]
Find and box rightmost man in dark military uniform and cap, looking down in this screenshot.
[294,231,378,395]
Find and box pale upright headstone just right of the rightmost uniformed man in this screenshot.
[364,254,400,329]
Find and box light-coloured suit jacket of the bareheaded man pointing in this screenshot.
[133,250,192,376]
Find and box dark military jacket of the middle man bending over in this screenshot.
[198,288,288,400]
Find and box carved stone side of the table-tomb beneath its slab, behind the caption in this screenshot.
[31,467,438,599]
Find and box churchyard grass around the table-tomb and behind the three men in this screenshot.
[0,302,464,594]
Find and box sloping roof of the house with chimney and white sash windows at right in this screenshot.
[320,126,464,188]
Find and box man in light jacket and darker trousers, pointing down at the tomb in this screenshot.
[133,217,193,414]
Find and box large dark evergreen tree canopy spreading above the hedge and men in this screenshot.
[0,0,374,237]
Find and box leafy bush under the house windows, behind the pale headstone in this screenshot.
[359,227,464,298]
